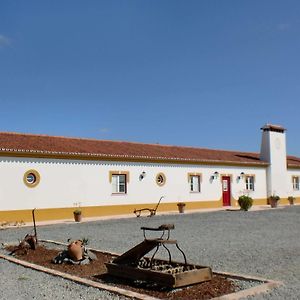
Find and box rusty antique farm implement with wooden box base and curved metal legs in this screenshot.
[106,224,212,288]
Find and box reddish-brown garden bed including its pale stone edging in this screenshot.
[0,240,281,300]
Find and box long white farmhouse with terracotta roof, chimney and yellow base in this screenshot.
[0,124,300,222]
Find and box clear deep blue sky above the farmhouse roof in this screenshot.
[0,0,300,156]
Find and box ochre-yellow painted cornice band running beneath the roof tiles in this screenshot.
[0,151,268,169]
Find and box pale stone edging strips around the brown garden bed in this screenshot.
[0,239,283,300]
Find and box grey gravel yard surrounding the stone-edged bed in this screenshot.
[0,205,300,300]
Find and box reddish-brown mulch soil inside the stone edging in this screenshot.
[6,244,236,300]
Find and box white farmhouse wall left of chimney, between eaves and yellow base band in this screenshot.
[0,157,267,211]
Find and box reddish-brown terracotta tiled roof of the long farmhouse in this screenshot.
[0,132,300,166]
